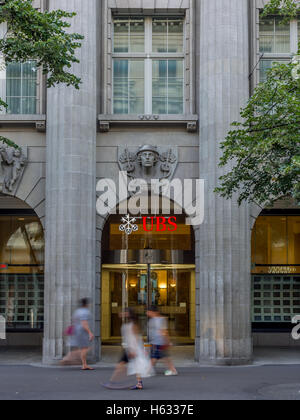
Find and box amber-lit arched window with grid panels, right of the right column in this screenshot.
[251,208,300,346]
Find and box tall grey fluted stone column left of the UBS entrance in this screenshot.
[43,0,100,364]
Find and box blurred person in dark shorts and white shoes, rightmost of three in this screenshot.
[147,306,178,376]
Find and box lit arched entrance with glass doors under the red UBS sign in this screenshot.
[101,208,196,345]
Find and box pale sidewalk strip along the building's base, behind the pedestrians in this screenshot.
[0,346,300,368]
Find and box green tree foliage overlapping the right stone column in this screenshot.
[216,0,300,206]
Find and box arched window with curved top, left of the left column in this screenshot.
[0,195,45,347]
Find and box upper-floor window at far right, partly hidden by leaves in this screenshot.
[259,17,300,82]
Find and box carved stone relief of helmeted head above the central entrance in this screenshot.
[118,145,178,182]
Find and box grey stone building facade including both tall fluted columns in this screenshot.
[0,0,299,364]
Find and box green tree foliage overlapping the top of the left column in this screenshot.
[0,0,83,146]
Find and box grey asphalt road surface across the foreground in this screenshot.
[0,365,300,401]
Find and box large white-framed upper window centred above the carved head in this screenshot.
[113,17,185,115]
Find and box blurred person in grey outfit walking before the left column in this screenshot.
[61,298,94,371]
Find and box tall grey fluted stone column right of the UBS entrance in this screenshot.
[196,0,252,364]
